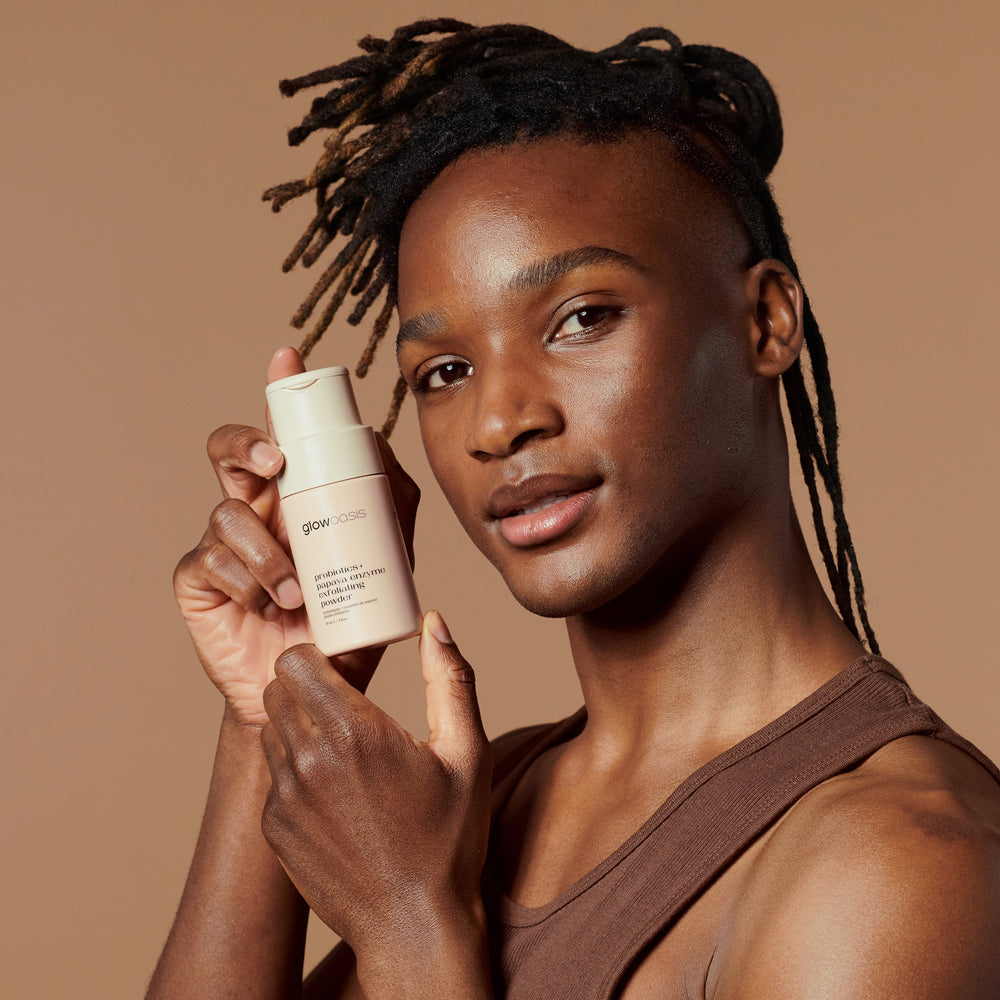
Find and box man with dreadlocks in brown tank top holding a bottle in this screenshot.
[151,21,1000,1000]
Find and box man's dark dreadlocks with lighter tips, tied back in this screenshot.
[263,18,879,653]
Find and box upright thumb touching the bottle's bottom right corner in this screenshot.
[420,611,487,765]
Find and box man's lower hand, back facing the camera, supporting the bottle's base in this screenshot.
[261,612,492,985]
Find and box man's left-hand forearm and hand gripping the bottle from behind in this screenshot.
[148,349,410,1000]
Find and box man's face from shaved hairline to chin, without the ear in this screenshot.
[398,133,760,616]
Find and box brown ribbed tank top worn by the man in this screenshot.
[484,656,1000,1000]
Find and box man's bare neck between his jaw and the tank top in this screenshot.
[567,501,864,764]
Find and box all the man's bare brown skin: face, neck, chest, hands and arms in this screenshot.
[150,134,1000,1000]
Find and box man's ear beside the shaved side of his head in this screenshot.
[746,259,805,378]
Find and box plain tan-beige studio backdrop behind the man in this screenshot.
[0,0,1000,998]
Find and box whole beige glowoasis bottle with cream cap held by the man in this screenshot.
[267,366,422,656]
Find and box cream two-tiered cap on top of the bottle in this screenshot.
[267,365,385,497]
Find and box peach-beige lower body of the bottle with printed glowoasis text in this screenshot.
[281,476,422,656]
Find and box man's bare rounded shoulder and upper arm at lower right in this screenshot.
[708,736,1000,1000]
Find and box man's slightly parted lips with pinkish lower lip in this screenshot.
[487,474,601,547]
